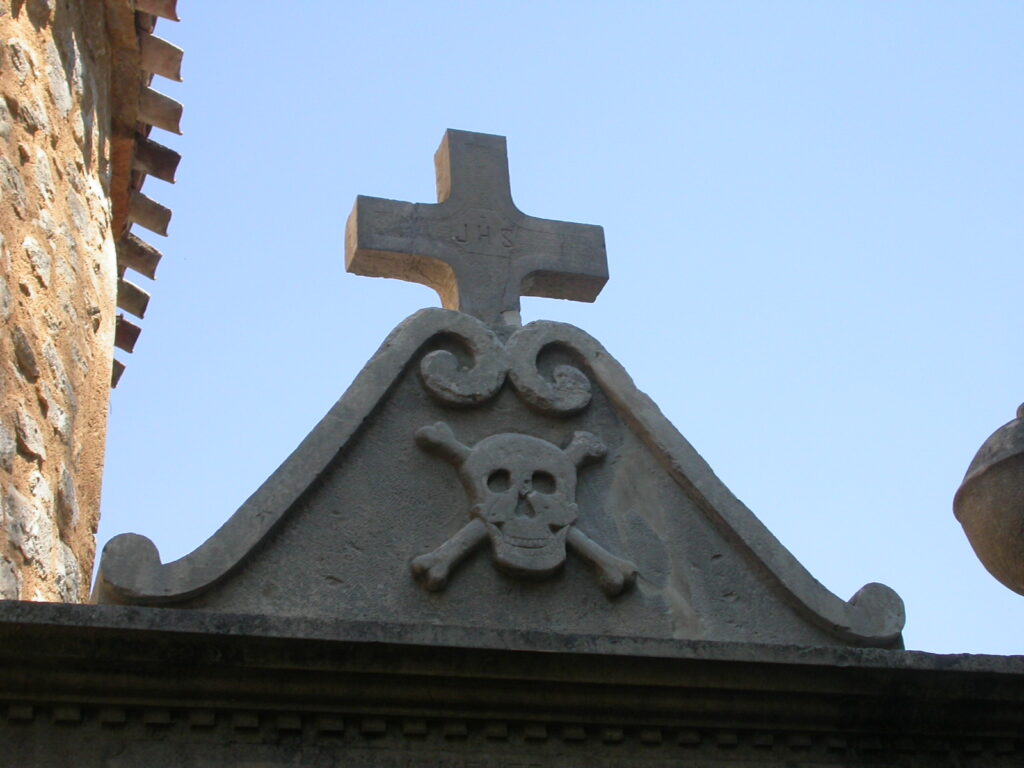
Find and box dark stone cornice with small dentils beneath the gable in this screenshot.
[6,602,1024,768]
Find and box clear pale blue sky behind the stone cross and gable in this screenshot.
[99,0,1024,653]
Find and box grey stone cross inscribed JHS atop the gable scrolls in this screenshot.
[345,130,608,325]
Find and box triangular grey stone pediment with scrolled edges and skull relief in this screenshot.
[94,309,904,647]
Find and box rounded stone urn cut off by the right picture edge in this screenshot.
[953,404,1024,595]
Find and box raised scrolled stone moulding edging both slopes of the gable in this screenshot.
[94,309,904,645]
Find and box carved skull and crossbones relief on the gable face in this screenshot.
[412,422,637,597]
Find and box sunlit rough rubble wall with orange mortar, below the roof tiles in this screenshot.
[0,0,117,602]
